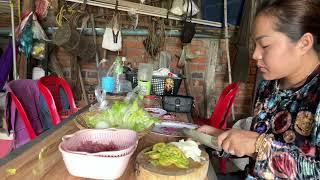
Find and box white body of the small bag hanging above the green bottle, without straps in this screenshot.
[102,27,122,51]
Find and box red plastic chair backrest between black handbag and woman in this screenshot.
[210,82,240,129]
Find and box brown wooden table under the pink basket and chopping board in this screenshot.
[0,109,216,180]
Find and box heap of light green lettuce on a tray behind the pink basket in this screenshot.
[75,100,159,138]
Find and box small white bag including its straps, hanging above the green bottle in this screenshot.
[102,12,122,51]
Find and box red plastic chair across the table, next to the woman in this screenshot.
[194,82,240,173]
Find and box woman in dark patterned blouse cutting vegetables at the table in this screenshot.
[198,0,320,179]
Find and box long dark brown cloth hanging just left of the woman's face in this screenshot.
[232,0,253,82]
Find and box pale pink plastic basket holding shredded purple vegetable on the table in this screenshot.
[59,129,138,179]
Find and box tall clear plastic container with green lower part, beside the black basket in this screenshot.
[137,63,153,96]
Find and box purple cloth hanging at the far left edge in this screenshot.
[0,40,13,90]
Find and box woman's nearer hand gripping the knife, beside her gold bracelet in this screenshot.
[218,129,259,157]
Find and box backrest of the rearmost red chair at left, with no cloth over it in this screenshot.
[39,75,77,113]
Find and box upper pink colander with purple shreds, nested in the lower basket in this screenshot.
[60,129,138,157]
